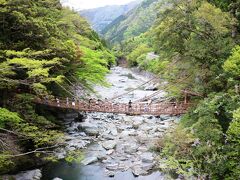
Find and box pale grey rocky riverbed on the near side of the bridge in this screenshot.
[59,113,178,177]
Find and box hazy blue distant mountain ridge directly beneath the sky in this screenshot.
[79,0,142,34]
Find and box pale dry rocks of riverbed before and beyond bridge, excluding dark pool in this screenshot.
[52,67,179,177]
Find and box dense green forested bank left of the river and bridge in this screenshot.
[0,0,115,173]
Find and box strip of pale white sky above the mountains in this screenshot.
[61,0,138,10]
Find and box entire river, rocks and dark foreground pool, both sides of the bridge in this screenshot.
[7,67,179,180]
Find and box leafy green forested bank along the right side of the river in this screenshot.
[118,0,240,179]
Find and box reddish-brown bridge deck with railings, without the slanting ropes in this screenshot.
[35,99,191,116]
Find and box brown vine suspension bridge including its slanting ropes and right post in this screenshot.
[35,75,201,116]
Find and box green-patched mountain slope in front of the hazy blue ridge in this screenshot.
[102,0,161,44]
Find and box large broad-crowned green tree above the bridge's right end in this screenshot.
[153,0,234,93]
